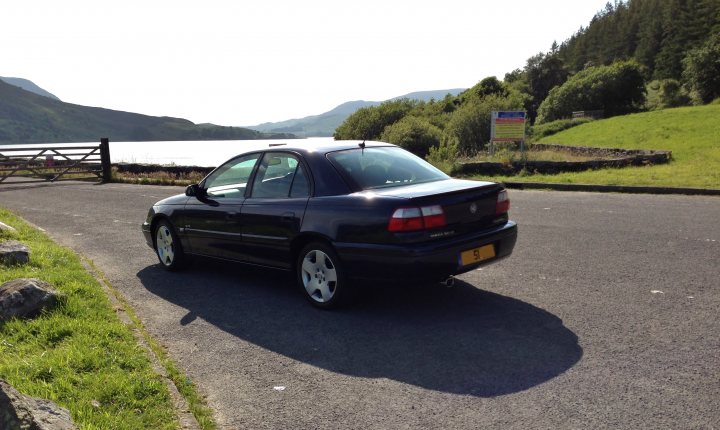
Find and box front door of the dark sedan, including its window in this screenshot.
[182,153,262,259]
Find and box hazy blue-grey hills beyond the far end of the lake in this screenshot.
[247,88,465,137]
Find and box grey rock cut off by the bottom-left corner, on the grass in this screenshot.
[0,379,77,430]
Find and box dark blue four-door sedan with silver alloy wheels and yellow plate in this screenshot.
[142,141,517,308]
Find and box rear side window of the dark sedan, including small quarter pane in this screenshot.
[250,152,309,199]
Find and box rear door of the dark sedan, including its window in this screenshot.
[241,152,311,268]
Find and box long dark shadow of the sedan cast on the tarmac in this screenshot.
[137,262,582,397]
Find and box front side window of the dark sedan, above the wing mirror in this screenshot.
[204,154,260,199]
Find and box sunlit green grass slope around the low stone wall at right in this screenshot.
[466,104,720,189]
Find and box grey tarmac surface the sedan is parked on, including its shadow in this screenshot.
[0,182,720,429]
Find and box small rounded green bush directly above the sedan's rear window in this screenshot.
[380,116,442,157]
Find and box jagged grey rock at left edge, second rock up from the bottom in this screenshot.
[0,278,59,321]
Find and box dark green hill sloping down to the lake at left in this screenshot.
[0,78,294,144]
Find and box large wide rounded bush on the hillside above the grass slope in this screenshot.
[536,61,645,124]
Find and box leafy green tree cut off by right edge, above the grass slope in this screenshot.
[683,32,720,103]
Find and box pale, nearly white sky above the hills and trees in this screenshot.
[0,0,607,126]
